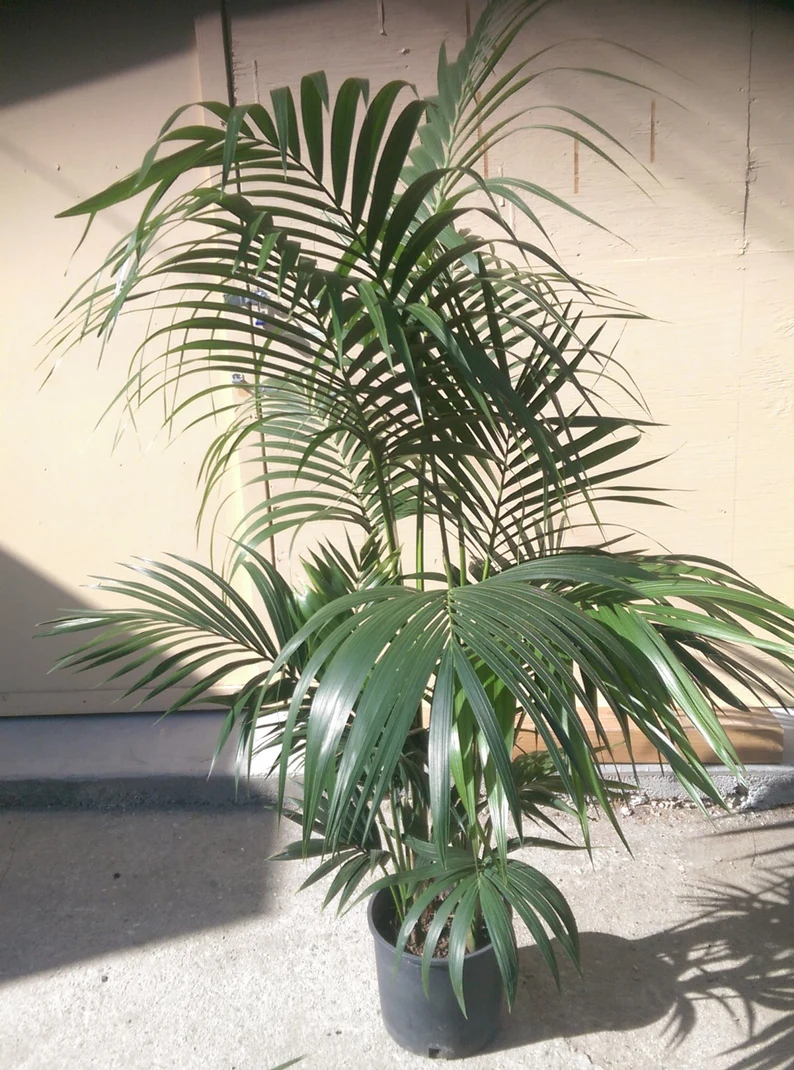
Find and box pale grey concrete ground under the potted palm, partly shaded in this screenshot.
[0,804,794,1070]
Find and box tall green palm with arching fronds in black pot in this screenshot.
[42,0,794,1055]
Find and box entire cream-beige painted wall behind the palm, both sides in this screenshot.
[0,0,794,714]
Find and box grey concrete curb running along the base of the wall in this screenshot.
[0,712,794,810]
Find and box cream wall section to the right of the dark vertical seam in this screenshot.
[229,0,794,601]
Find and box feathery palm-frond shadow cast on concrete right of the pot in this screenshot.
[494,843,794,1070]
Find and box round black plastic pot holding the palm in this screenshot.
[367,888,503,1059]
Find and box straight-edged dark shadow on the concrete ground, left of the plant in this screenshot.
[0,809,275,984]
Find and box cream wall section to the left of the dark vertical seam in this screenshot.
[0,0,233,716]
